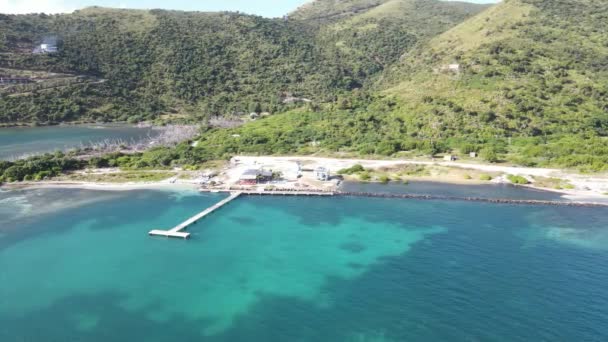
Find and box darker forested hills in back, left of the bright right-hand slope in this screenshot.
[0,0,483,123]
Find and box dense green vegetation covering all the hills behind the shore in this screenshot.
[0,0,608,171]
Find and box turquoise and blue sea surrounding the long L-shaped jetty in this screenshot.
[0,190,608,341]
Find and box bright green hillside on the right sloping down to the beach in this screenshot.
[190,0,608,171]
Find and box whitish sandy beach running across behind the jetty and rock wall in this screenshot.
[4,156,608,201]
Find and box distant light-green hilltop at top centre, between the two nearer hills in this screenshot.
[306,0,486,86]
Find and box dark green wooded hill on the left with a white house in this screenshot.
[0,8,332,123]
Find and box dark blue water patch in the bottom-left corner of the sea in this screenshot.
[0,293,218,342]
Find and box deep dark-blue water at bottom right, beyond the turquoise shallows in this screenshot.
[217,217,608,342]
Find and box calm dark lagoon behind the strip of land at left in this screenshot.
[0,124,158,160]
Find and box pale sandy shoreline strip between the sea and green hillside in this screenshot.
[0,156,608,205]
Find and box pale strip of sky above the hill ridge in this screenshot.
[0,0,498,17]
